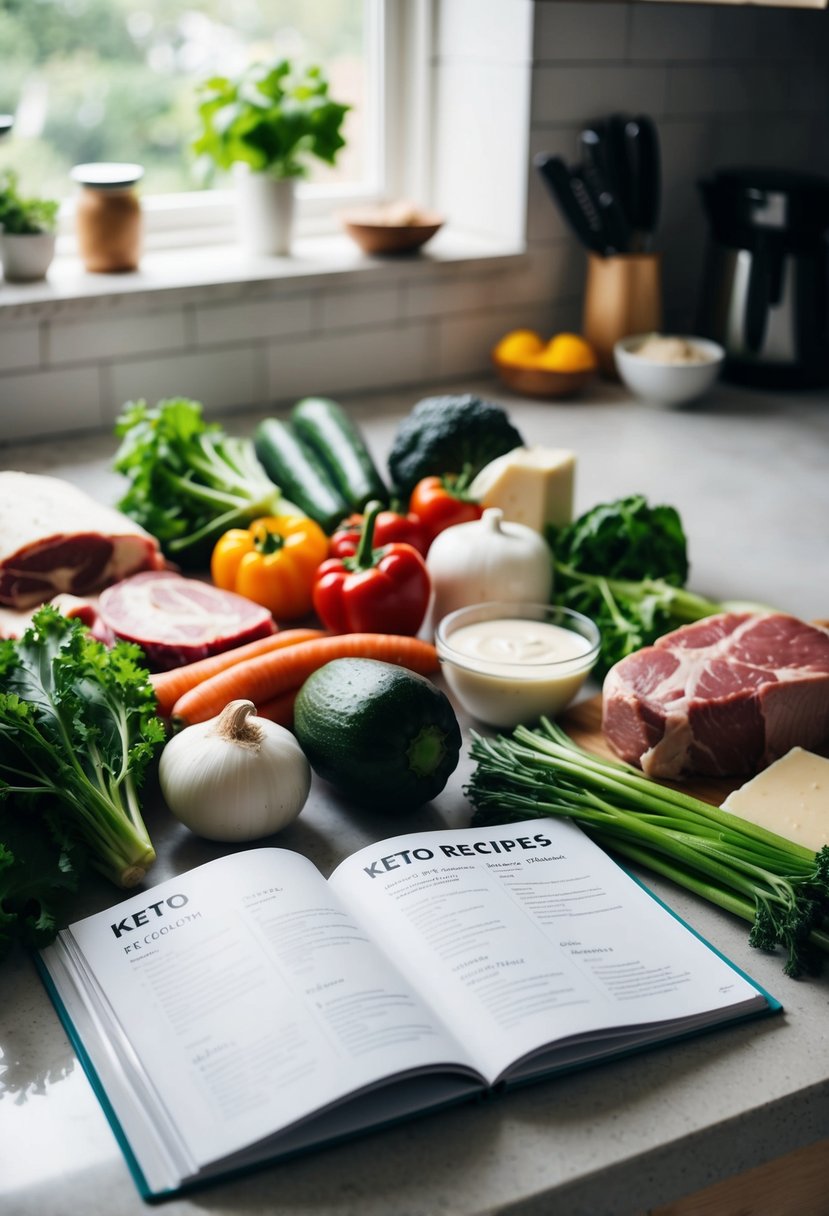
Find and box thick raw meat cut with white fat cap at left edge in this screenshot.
[0,469,164,608]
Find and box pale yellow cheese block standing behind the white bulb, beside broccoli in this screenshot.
[469,446,576,531]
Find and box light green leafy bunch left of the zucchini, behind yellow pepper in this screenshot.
[114,398,304,569]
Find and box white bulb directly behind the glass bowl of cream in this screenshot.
[427,507,553,625]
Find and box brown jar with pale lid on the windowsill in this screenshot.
[72,163,143,274]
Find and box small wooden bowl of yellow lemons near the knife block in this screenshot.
[492,330,598,400]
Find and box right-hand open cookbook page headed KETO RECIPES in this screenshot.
[329,820,757,1082]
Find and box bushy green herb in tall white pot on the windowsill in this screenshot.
[192,60,351,254]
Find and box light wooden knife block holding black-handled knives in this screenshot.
[581,253,662,379]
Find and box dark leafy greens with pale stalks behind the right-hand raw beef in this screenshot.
[546,494,763,680]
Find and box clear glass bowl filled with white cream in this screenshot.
[435,601,600,728]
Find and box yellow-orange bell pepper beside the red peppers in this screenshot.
[210,516,328,620]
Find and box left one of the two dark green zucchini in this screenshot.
[253,418,351,533]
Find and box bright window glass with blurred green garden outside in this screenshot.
[0,0,417,244]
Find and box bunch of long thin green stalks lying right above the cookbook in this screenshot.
[466,717,829,976]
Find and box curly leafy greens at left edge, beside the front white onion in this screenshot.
[0,606,164,956]
